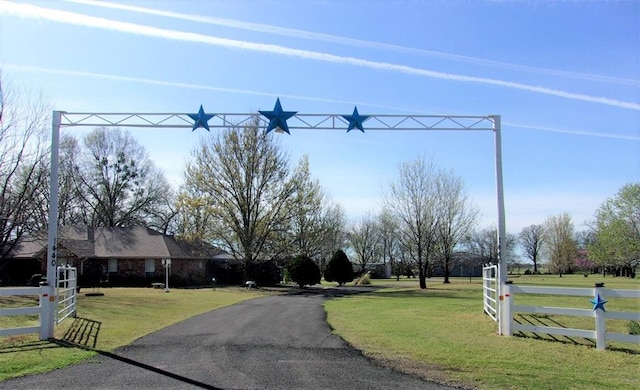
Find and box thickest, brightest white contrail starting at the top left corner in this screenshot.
[0,1,640,111]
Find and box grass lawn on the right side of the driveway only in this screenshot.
[325,275,640,389]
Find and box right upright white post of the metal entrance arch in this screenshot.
[491,115,508,335]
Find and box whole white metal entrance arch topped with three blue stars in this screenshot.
[43,99,507,337]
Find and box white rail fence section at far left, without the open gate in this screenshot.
[0,286,49,340]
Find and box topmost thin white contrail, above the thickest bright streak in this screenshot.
[64,0,640,86]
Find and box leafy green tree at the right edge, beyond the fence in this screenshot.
[588,182,640,276]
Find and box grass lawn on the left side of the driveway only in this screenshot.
[0,288,260,381]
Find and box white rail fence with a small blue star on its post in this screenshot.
[504,284,640,350]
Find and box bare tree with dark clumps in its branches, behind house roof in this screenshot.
[66,128,172,226]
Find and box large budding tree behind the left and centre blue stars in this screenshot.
[185,123,296,277]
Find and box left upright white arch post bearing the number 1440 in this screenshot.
[42,111,61,338]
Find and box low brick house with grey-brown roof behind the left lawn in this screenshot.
[3,226,229,287]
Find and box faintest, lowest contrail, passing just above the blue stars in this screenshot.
[4,64,640,141]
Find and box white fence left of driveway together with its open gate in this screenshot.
[0,266,77,340]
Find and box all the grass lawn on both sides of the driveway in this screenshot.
[0,275,640,389]
